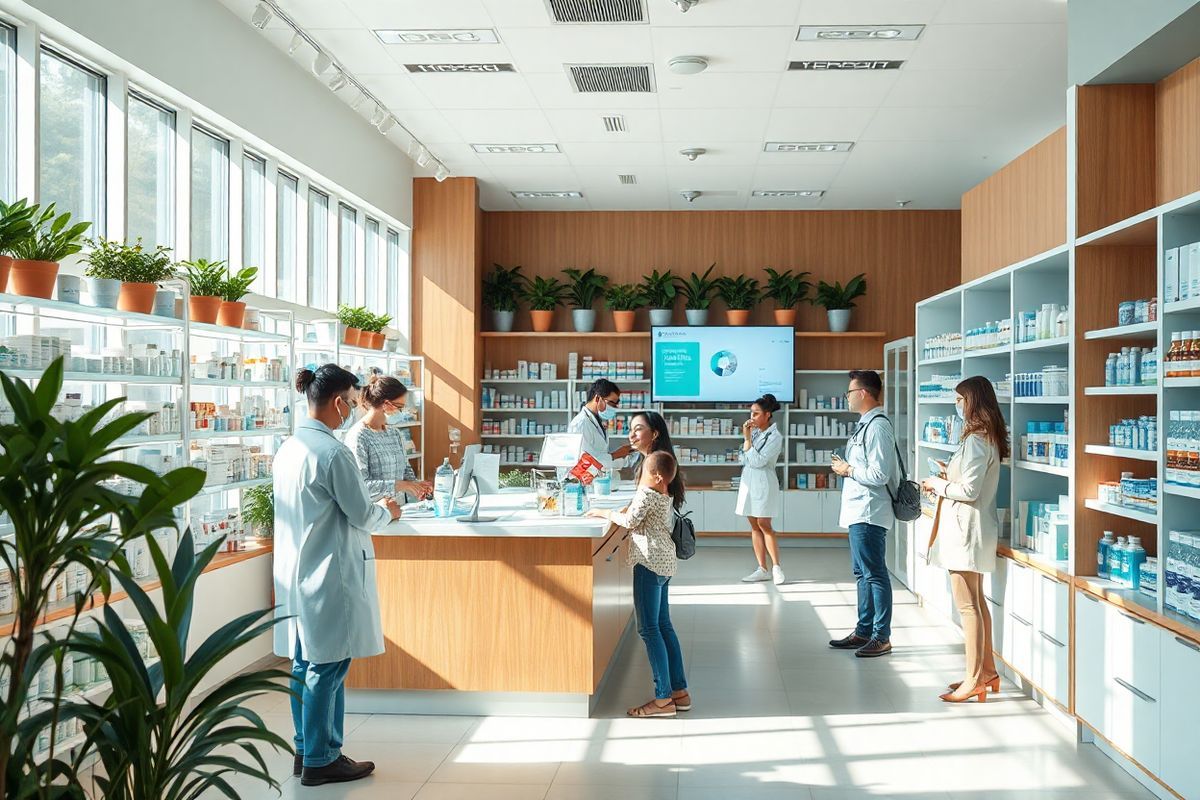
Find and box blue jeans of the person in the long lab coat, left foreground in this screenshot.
[292,637,350,766]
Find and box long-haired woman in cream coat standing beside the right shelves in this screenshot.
[923,375,1009,703]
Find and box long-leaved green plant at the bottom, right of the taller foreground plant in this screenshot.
[67,530,290,800]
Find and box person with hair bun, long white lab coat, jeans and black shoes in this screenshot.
[274,363,400,786]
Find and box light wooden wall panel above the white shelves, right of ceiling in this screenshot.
[961,127,1067,283]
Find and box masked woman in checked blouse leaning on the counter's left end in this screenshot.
[346,375,433,500]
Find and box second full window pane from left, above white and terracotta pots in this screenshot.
[126,94,175,247]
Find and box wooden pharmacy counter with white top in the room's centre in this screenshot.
[347,492,632,716]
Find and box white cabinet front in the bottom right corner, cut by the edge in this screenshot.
[1159,630,1200,798]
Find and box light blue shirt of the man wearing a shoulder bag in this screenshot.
[838,407,900,529]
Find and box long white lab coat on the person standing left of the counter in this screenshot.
[274,417,391,663]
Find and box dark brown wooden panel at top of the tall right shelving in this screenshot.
[1075,84,1157,236]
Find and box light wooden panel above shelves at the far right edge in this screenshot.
[1154,59,1200,205]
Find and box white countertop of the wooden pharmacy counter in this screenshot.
[373,491,634,539]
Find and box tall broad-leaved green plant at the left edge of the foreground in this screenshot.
[0,359,204,798]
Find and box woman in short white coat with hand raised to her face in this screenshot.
[736,395,785,585]
